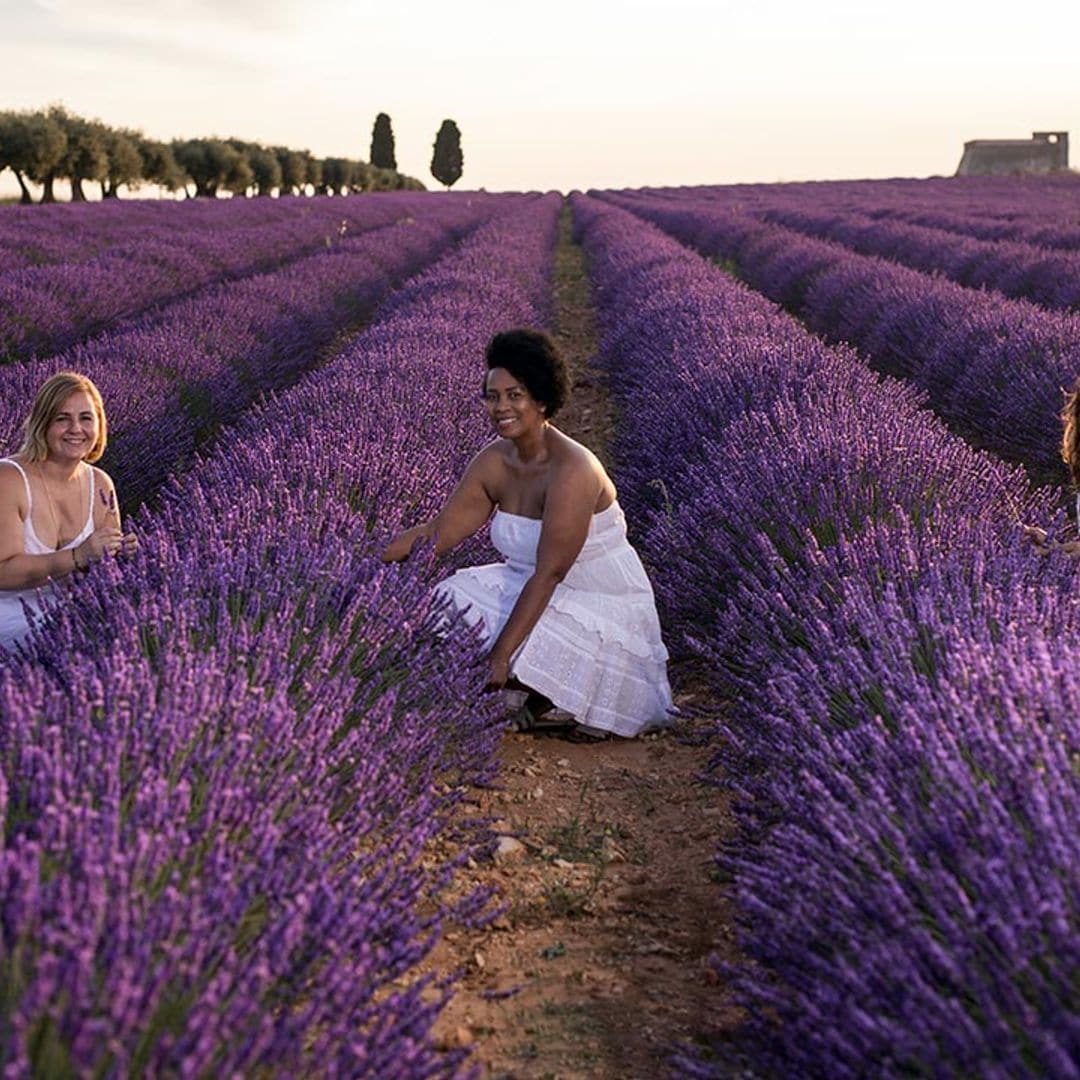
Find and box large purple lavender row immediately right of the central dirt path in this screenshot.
[575,197,1080,1080]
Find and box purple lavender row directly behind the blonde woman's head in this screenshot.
[0,200,494,507]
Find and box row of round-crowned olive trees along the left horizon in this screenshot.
[0,105,423,203]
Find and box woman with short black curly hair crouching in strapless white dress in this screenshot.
[382,329,672,737]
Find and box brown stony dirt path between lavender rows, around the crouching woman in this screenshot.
[425,204,738,1080]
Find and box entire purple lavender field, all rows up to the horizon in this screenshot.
[0,178,1080,1078]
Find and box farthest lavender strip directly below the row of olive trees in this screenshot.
[0,199,386,270]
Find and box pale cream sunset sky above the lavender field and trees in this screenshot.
[0,0,1080,191]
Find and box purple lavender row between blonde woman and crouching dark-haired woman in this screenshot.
[0,197,558,1078]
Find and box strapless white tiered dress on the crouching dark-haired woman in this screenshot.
[436,502,672,737]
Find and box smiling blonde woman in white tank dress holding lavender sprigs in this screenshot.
[0,372,135,654]
